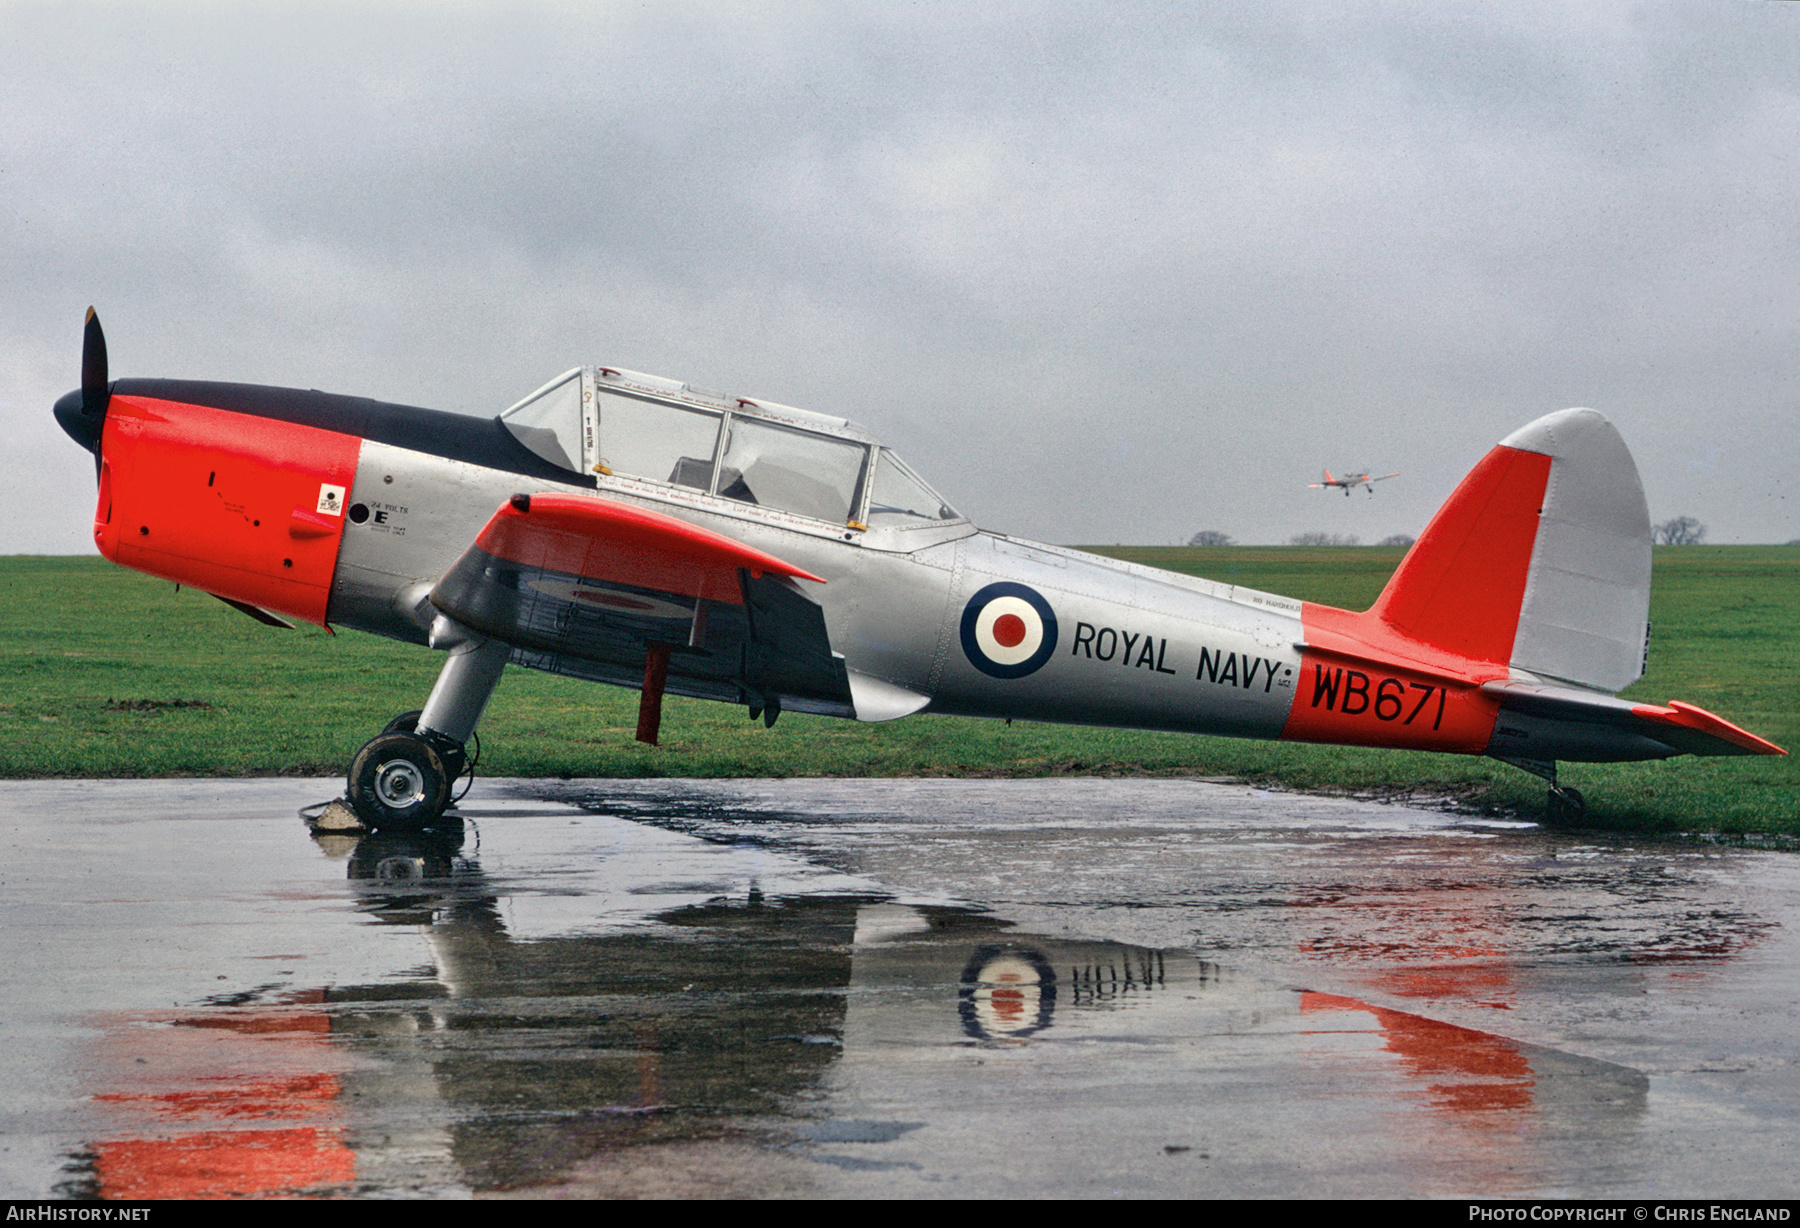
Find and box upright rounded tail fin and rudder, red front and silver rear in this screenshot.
[1370,409,1651,691]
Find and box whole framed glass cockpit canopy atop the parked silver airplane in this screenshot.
[500,367,961,528]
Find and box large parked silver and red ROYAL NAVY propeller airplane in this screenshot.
[54,308,1786,830]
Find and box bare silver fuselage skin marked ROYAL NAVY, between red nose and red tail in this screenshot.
[329,441,1301,738]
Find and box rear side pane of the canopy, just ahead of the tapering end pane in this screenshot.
[718,418,868,524]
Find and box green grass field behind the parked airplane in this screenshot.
[0,546,1800,834]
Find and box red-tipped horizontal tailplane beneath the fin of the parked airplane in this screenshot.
[1481,681,1787,762]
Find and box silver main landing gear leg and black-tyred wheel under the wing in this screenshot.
[349,614,511,832]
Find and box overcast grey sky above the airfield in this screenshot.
[0,0,1800,553]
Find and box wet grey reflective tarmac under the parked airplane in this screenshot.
[0,780,1800,1197]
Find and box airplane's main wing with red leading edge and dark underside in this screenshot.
[432,495,855,742]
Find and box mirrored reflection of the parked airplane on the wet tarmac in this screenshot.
[65,817,1645,1199]
